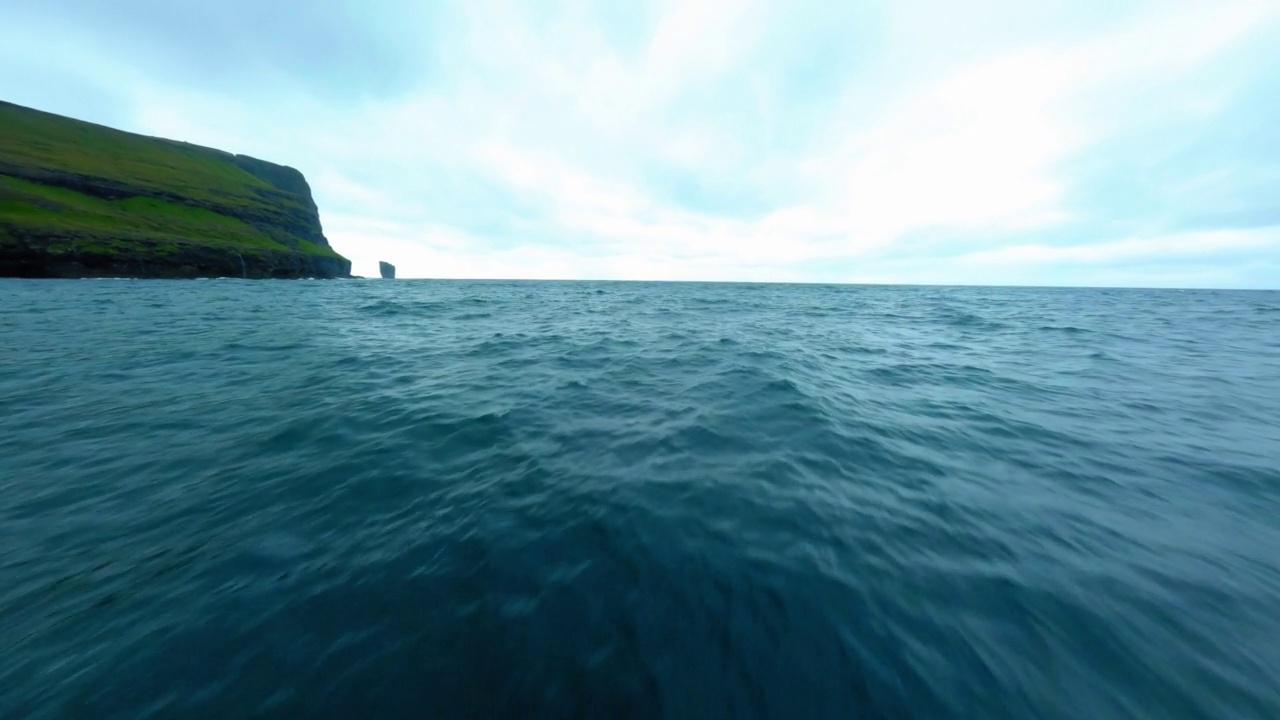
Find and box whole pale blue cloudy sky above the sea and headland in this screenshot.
[0,0,1280,288]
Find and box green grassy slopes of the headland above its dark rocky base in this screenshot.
[0,102,342,265]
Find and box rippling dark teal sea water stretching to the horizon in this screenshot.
[0,281,1280,719]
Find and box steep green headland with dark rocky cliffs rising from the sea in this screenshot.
[0,101,351,278]
